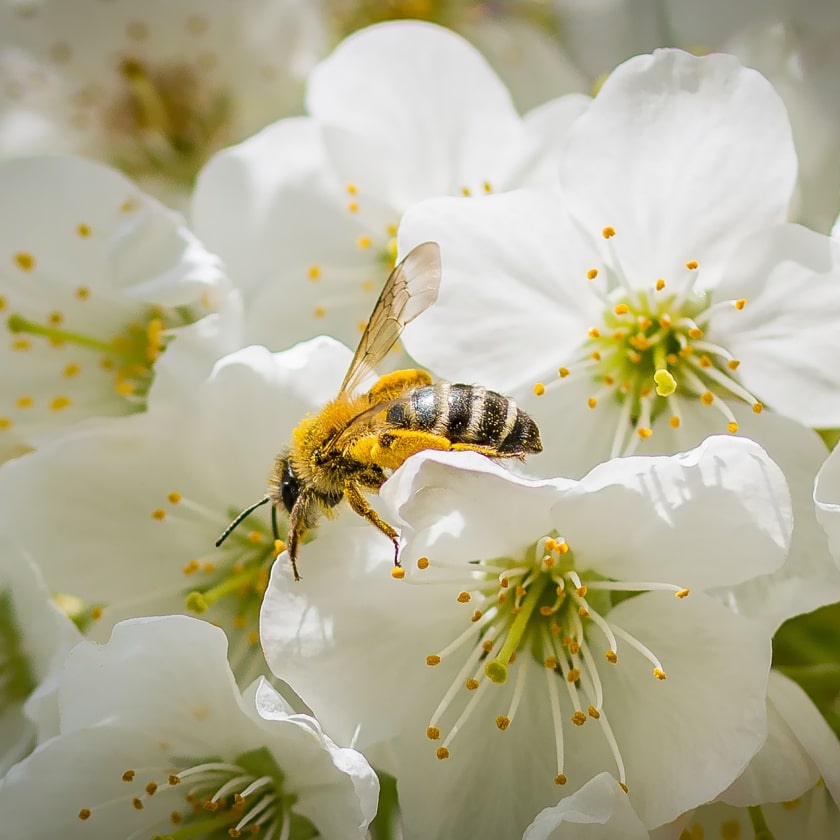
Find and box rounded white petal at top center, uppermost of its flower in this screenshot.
[306,21,536,209]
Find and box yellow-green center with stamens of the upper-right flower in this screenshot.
[543,227,763,457]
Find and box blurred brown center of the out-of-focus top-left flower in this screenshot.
[103,58,236,186]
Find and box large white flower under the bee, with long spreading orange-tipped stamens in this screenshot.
[261,437,791,838]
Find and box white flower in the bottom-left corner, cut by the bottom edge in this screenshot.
[0,616,378,840]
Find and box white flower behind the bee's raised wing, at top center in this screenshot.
[193,21,583,349]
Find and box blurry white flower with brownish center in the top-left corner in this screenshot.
[0,0,326,199]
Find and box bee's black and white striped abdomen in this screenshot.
[386,382,542,456]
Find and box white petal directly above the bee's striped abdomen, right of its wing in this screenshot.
[399,190,601,392]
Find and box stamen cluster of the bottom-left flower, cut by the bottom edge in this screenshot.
[77,748,317,840]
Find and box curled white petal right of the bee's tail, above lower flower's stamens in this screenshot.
[552,437,793,589]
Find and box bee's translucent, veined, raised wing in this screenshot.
[340,242,440,394]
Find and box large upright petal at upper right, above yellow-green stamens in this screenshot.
[561,50,796,285]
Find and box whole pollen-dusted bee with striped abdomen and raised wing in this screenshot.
[216,242,542,580]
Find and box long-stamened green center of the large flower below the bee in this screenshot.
[417,536,689,789]
